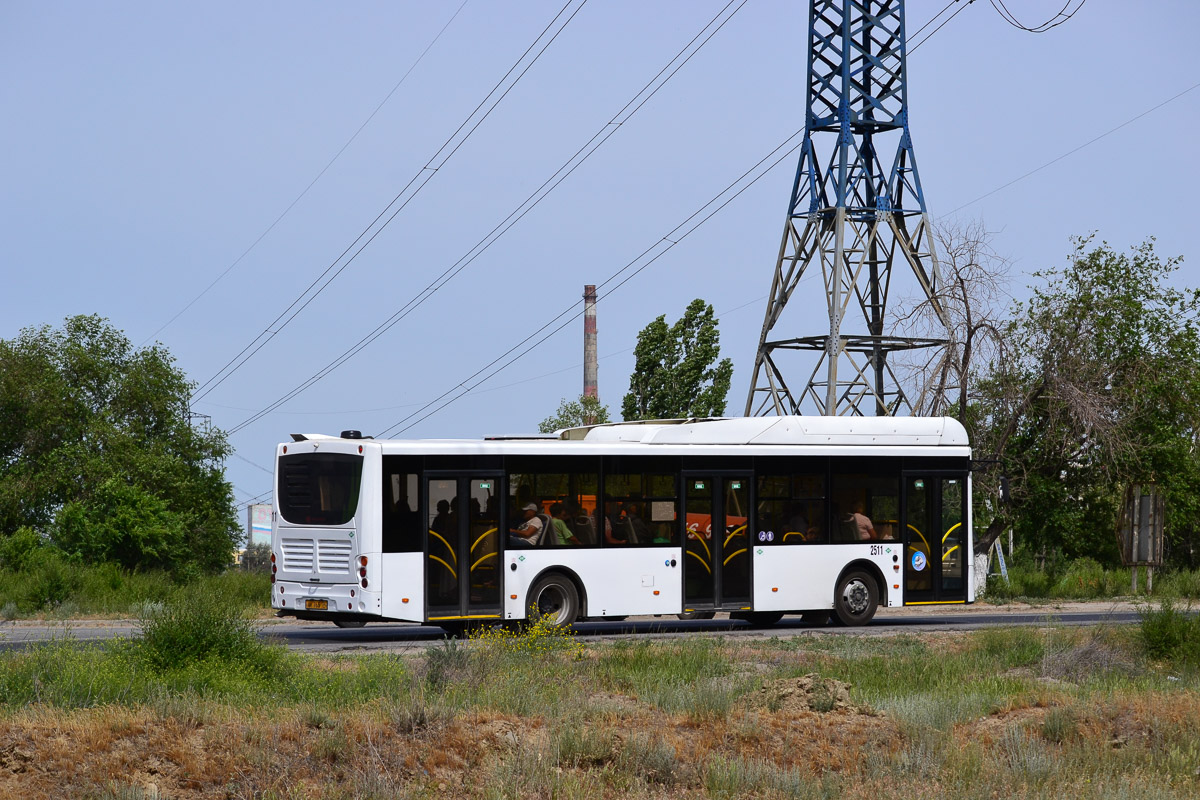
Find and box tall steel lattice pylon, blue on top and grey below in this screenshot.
[745,0,946,416]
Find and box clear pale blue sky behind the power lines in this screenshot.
[0,0,1200,500]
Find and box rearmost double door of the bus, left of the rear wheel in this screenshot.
[425,474,502,621]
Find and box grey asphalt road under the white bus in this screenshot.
[0,602,1138,654]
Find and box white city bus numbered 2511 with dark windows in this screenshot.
[271,416,974,630]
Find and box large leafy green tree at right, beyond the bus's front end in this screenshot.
[970,239,1200,563]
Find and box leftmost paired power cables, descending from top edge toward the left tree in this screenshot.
[192,0,587,402]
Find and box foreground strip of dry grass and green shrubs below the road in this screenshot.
[0,591,1200,800]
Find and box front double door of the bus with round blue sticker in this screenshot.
[902,473,971,604]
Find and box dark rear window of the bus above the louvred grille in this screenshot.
[276,453,362,525]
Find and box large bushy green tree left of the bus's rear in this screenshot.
[0,315,239,570]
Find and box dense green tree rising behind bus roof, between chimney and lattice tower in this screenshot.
[620,299,733,420]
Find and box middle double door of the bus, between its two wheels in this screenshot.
[683,474,751,612]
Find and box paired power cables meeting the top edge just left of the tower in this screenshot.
[229,0,748,434]
